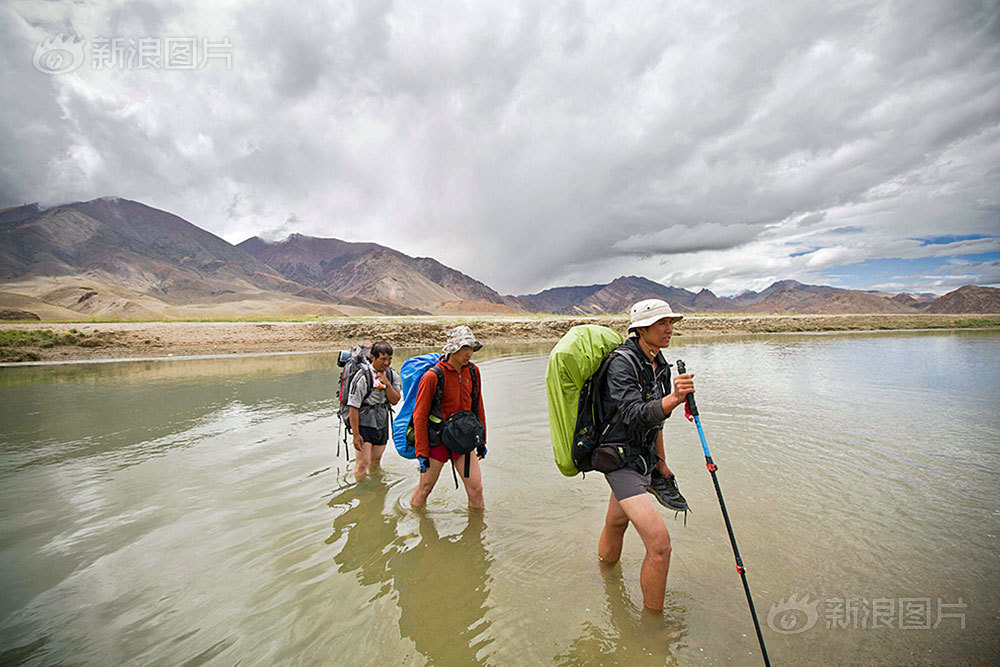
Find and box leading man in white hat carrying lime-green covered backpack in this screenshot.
[546,299,694,610]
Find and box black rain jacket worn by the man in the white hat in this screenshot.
[600,337,670,466]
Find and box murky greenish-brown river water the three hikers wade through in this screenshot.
[0,332,1000,665]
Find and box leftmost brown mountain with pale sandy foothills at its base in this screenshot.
[0,198,343,319]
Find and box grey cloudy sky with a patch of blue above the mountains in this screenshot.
[0,0,1000,294]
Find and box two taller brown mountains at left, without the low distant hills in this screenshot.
[0,197,524,319]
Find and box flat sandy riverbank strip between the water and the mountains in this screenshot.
[0,314,1000,362]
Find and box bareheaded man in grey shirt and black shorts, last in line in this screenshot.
[344,340,402,481]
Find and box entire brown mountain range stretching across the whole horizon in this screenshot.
[0,198,1000,319]
